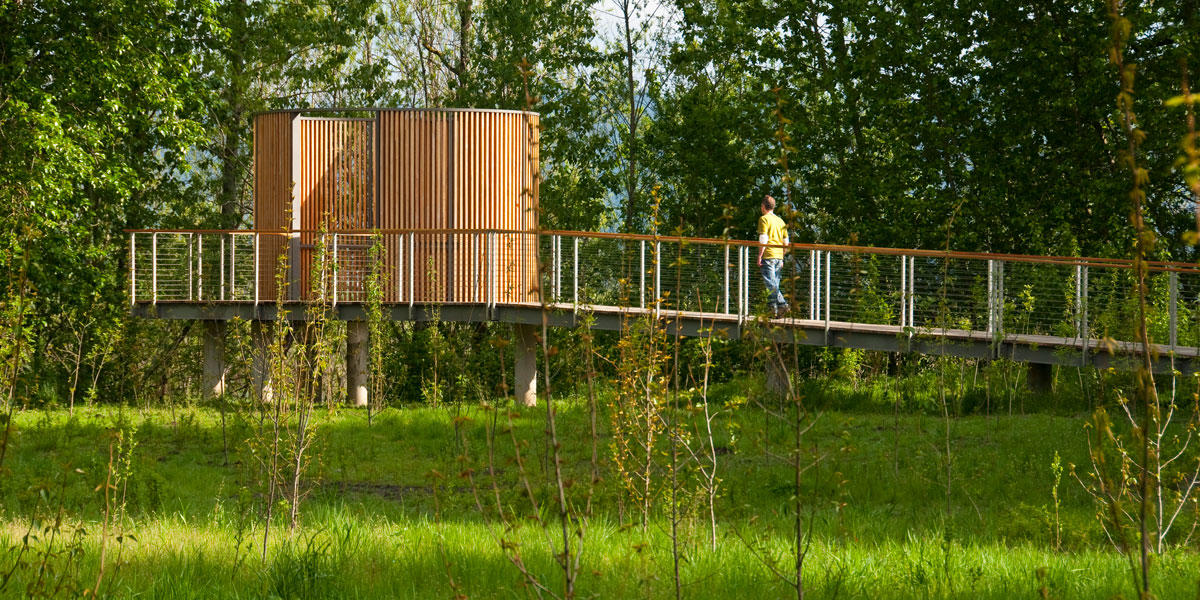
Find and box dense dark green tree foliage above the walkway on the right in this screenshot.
[649,0,1200,256]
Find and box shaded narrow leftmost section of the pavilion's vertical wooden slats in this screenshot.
[253,113,293,301]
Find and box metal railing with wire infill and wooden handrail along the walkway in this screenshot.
[130,230,1200,348]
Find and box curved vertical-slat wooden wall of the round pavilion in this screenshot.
[254,109,539,304]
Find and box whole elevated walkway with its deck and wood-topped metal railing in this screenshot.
[130,229,1200,403]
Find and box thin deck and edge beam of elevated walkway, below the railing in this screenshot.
[132,301,1200,373]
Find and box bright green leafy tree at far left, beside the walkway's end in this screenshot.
[0,0,204,379]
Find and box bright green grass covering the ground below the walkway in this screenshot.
[0,383,1200,599]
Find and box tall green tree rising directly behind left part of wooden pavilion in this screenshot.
[194,0,383,228]
